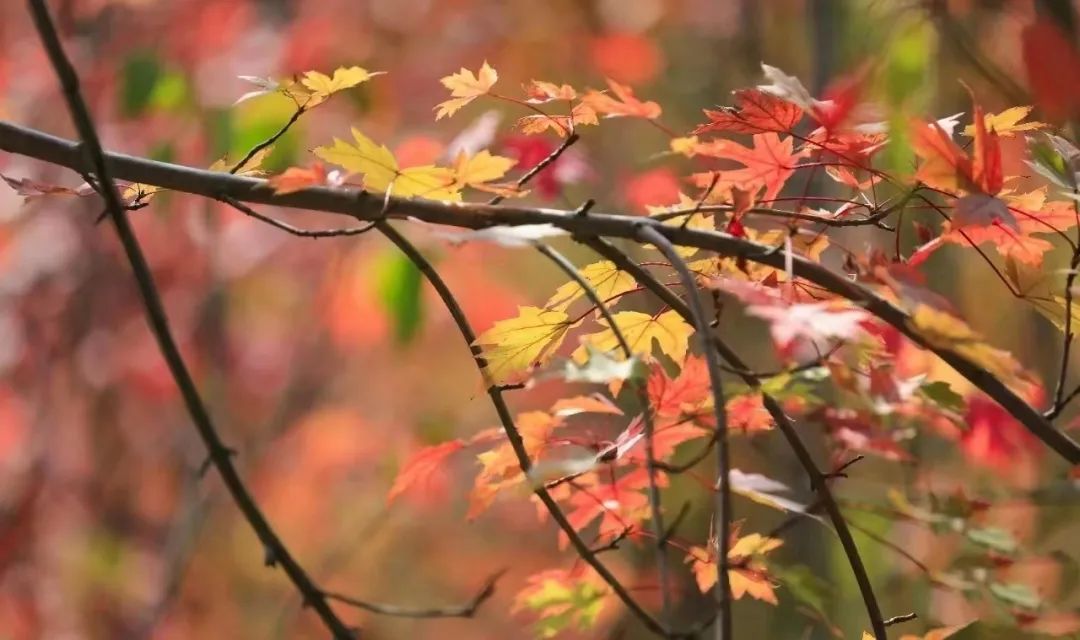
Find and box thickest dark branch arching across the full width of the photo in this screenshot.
[0,117,1080,464]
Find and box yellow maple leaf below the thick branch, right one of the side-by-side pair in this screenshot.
[572,311,693,363]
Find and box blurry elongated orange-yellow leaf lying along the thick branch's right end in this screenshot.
[908,304,1027,386]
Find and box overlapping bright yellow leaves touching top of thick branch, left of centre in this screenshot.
[314,127,461,202]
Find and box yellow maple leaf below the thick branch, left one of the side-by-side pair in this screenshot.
[475,307,571,384]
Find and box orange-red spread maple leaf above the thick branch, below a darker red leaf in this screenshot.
[697,133,802,200]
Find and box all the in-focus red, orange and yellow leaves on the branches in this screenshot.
[4,41,1080,638]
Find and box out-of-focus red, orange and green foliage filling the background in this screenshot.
[0,0,1080,640]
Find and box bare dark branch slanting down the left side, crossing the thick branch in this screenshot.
[27,0,355,640]
